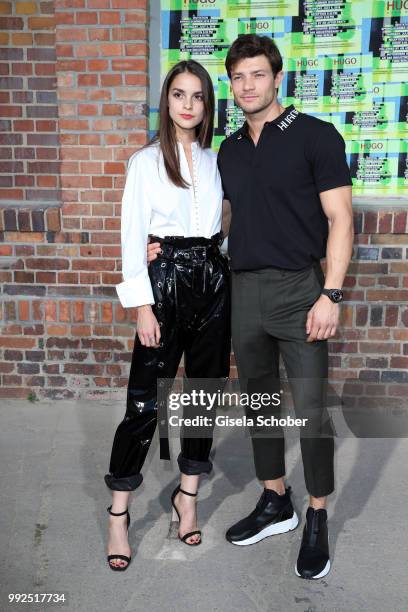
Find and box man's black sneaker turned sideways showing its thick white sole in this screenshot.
[225,487,299,546]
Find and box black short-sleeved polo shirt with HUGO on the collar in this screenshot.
[218,105,352,270]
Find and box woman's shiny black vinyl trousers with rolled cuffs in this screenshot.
[105,233,231,491]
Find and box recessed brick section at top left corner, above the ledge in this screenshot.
[0,0,61,203]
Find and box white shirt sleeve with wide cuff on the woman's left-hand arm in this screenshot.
[116,154,154,308]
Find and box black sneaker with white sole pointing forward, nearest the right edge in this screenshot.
[295,507,330,579]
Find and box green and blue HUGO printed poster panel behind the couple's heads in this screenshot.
[150,0,408,196]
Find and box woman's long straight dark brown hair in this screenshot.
[142,60,215,188]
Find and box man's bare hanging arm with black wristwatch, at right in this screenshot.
[306,185,354,342]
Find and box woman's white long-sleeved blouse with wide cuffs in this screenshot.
[116,141,223,308]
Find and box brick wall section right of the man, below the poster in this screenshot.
[330,209,408,412]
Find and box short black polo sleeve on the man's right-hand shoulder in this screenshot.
[311,123,353,193]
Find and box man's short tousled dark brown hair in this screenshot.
[225,34,283,78]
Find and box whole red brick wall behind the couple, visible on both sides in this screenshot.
[0,0,408,398]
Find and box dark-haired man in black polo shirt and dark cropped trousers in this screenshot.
[149,34,353,579]
